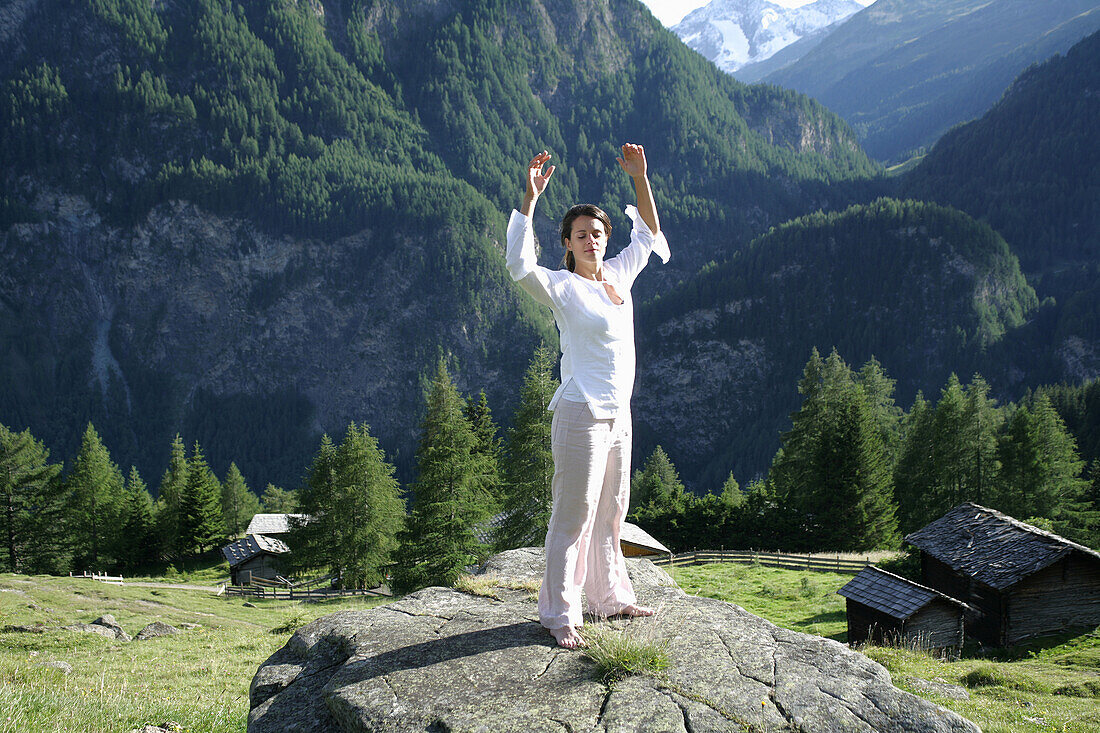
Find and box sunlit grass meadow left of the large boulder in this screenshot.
[0,575,391,733]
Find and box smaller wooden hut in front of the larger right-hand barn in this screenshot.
[837,566,967,654]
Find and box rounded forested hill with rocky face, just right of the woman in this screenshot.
[634,199,1038,488]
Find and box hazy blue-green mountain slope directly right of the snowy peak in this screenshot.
[762,0,1100,161]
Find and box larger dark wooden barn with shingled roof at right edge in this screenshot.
[905,502,1100,646]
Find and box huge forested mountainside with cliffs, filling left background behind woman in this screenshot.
[0,0,877,485]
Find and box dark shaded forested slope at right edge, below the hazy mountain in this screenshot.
[902,27,1100,281]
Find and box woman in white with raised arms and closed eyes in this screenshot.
[507,144,669,648]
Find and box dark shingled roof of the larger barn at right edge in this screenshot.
[905,502,1100,590]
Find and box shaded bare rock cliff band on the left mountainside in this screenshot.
[0,182,538,486]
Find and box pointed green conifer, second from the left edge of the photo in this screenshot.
[67,423,123,570]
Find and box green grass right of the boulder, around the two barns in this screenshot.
[672,564,1100,733]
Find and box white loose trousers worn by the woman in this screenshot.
[539,400,637,628]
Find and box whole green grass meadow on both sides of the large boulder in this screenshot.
[0,564,1100,733]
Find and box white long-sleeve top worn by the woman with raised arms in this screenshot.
[507,206,669,419]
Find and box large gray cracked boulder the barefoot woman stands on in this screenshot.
[249,549,978,733]
